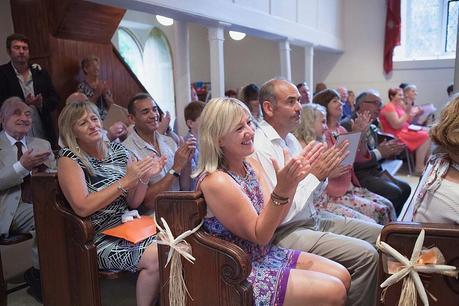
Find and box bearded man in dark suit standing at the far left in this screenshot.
[0,34,59,147]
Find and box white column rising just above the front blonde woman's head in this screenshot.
[208,27,225,98]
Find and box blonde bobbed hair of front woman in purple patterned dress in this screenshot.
[193,97,250,177]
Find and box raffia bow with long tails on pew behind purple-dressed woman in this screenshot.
[155,218,203,306]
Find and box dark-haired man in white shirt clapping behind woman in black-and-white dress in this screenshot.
[123,93,196,209]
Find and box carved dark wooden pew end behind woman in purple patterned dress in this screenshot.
[155,192,252,306]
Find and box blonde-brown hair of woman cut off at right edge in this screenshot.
[430,95,459,153]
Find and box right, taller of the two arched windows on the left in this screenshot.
[143,28,176,122]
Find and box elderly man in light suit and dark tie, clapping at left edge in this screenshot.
[0,97,55,299]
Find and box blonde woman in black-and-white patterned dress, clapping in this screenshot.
[58,101,164,305]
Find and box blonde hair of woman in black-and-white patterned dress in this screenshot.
[58,101,106,175]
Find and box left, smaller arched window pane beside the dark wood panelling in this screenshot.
[117,27,144,83]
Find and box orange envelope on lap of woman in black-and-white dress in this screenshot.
[102,216,156,244]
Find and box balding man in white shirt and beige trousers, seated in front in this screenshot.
[254,80,382,306]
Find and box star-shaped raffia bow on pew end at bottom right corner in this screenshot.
[376,229,459,306]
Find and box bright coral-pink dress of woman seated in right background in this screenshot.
[379,102,429,151]
